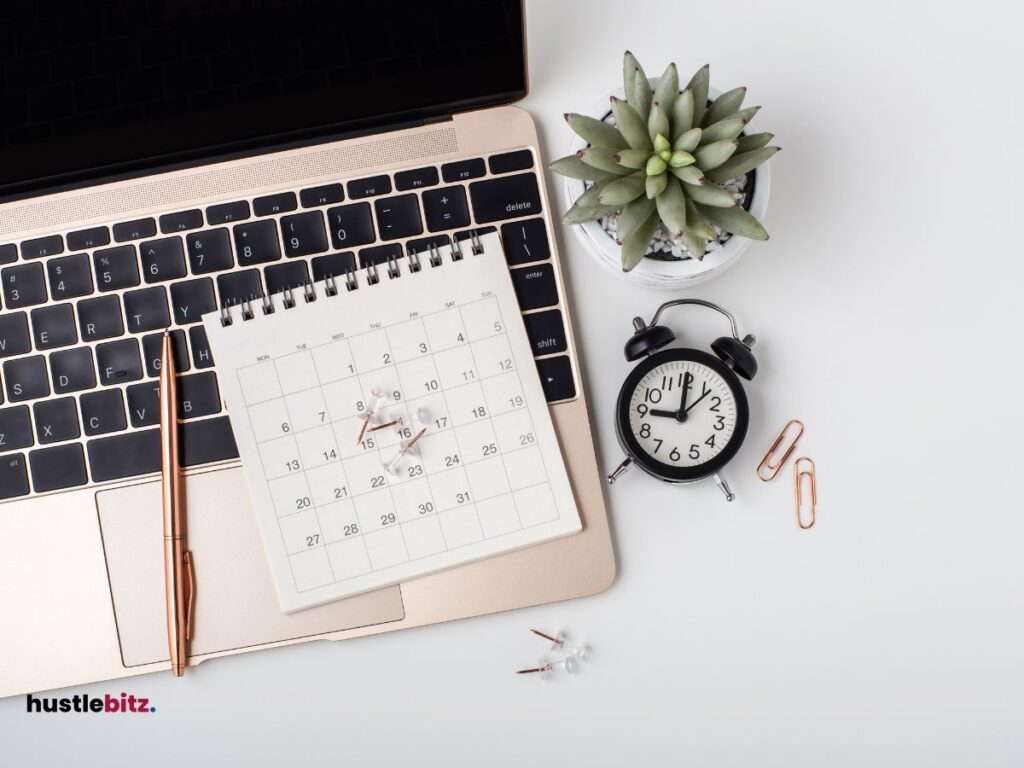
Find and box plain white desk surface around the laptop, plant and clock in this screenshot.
[0,0,1024,768]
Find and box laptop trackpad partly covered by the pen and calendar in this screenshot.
[96,468,406,667]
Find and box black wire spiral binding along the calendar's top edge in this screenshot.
[220,229,483,328]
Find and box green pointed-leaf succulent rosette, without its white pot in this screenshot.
[550,51,778,271]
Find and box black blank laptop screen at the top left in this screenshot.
[0,0,526,198]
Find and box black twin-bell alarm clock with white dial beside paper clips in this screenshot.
[608,299,758,502]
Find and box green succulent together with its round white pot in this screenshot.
[550,51,778,288]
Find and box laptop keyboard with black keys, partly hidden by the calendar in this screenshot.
[0,150,577,500]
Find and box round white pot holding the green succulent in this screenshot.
[564,79,771,291]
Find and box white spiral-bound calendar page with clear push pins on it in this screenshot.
[204,233,582,612]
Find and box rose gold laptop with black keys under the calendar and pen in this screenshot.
[0,0,614,696]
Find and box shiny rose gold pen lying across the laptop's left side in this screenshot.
[160,331,196,677]
